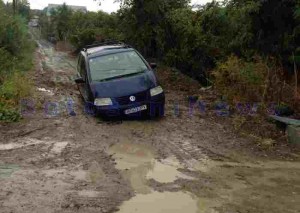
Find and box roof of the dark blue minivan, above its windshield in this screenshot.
[83,44,133,58]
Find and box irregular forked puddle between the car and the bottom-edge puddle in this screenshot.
[109,142,192,194]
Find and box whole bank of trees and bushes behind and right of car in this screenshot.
[42,0,300,111]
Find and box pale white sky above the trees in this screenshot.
[5,0,212,13]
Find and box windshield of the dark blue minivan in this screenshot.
[89,51,147,81]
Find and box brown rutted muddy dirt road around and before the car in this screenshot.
[0,38,300,213]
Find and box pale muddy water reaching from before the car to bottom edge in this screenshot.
[109,141,198,213]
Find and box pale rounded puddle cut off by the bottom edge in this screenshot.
[118,192,199,213]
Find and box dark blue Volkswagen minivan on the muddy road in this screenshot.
[75,43,165,117]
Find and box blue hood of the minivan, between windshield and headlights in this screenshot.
[91,71,157,98]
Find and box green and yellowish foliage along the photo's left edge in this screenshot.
[0,0,35,121]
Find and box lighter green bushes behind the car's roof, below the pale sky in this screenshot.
[41,4,122,48]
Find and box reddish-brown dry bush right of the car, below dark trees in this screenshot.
[213,56,268,102]
